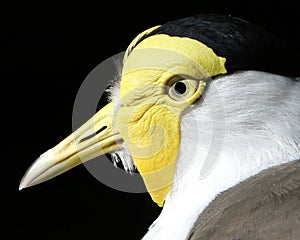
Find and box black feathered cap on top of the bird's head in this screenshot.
[139,14,299,76]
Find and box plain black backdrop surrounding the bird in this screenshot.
[11,0,300,239]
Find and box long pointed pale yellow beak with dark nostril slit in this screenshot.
[19,103,122,190]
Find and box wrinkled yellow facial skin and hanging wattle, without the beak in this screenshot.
[116,31,226,206]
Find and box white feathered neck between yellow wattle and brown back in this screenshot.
[144,71,300,240]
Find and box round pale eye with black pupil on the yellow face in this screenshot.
[167,77,199,101]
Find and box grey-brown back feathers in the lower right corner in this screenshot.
[189,160,300,240]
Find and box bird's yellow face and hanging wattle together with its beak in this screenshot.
[20,22,226,206]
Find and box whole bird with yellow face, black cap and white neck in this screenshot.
[19,14,300,240]
